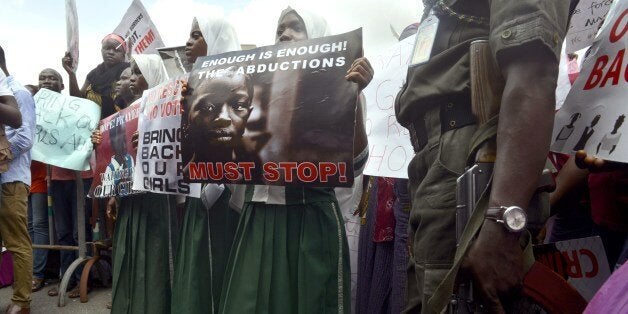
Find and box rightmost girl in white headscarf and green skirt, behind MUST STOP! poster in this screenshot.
[220,7,373,313]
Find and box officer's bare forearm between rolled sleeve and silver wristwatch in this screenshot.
[489,54,558,209]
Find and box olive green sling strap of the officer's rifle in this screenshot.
[426,116,534,313]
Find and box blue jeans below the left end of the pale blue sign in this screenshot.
[28,193,50,279]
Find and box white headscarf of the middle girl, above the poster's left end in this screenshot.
[194,16,241,56]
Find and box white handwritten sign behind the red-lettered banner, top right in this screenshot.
[565,0,613,53]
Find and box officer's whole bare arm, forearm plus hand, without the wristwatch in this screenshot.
[467,46,558,313]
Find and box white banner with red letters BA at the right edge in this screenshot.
[551,1,628,162]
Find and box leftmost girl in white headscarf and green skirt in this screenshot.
[107,55,174,313]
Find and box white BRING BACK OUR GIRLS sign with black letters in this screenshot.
[133,76,201,198]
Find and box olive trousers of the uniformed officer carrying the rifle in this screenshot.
[404,107,477,313]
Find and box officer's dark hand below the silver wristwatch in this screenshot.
[462,219,525,313]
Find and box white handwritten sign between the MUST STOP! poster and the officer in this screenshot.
[364,35,416,179]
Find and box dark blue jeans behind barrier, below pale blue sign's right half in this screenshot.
[52,179,92,286]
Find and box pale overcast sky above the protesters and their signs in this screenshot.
[0,0,422,92]
